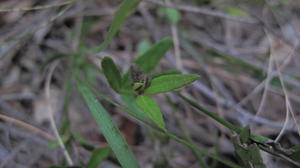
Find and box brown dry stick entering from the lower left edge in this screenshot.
[0,114,55,141]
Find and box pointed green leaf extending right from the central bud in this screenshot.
[144,74,199,95]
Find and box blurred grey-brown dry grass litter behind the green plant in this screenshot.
[0,0,300,168]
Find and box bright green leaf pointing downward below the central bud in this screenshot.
[136,95,165,130]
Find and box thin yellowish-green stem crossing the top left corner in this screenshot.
[0,0,76,13]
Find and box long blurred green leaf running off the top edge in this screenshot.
[92,0,141,53]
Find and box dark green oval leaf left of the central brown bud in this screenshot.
[101,57,122,93]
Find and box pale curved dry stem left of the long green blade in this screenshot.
[45,62,73,166]
